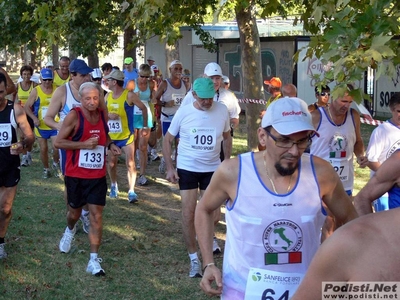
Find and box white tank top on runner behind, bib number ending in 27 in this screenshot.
[310,107,356,191]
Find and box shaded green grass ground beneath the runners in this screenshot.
[0,114,374,300]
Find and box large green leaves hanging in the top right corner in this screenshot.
[302,0,400,103]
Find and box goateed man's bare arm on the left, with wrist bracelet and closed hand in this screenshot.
[195,158,239,296]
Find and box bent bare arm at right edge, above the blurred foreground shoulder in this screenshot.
[354,151,400,215]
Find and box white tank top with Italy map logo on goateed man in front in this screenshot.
[222,152,325,299]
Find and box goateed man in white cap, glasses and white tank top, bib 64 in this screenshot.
[195,97,357,299]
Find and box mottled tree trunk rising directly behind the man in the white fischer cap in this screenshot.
[236,2,265,150]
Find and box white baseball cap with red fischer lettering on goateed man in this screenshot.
[261,97,319,136]
